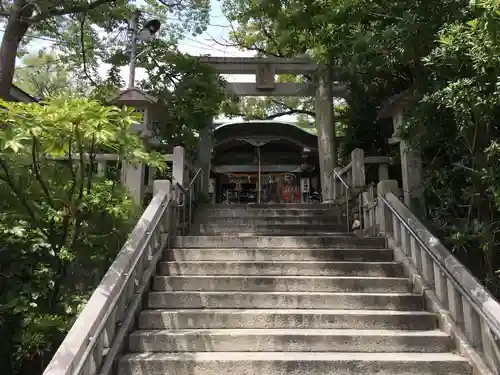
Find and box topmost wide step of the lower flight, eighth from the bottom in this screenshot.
[172,235,385,249]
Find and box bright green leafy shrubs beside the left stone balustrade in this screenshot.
[0,98,161,375]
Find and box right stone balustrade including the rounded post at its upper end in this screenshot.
[361,180,500,375]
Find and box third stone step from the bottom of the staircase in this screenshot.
[139,309,437,330]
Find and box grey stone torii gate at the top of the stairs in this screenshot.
[198,56,348,201]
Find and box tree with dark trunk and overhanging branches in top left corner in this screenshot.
[0,0,209,97]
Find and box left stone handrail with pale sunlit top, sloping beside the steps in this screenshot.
[43,181,176,375]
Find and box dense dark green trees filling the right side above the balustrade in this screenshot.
[225,0,500,296]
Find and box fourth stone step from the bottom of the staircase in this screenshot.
[147,291,424,311]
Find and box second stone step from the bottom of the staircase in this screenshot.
[129,329,452,353]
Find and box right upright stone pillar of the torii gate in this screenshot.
[315,68,336,201]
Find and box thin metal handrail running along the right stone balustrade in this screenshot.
[379,193,500,344]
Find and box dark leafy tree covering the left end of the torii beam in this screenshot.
[139,40,226,156]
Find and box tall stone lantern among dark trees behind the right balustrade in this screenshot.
[378,91,425,213]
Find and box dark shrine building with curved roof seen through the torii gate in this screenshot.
[211,121,320,204]
